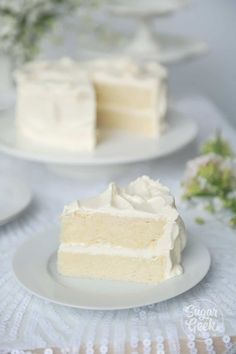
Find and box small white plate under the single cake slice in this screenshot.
[13,228,210,310]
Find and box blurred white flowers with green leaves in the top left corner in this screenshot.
[0,0,104,63]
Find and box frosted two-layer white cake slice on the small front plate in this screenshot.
[58,176,186,283]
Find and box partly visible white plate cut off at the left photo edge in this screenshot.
[0,175,32,225]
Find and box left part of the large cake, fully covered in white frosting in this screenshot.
[16,59,96,152]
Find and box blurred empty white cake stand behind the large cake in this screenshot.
[86,0,208,64]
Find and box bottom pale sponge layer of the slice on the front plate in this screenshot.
[58,251,182,283]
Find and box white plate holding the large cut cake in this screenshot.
[0,110,197,166]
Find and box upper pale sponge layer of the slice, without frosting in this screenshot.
[61,211,166,248]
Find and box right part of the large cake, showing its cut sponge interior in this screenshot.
[84,58,167,137]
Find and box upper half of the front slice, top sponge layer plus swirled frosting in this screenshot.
[61,176,185,249]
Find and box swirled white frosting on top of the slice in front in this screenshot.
[63,176,179,220]
